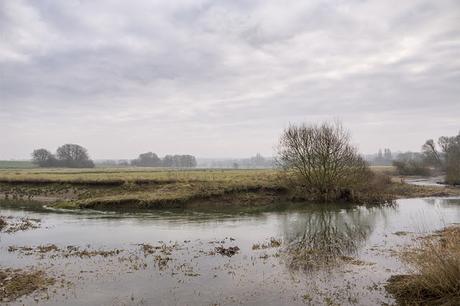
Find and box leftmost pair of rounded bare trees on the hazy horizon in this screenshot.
[32,144,94,168]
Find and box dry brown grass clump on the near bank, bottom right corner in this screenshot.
[386,226,460,305]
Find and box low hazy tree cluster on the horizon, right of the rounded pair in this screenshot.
[131,152,197,168]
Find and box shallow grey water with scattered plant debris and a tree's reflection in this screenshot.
[0,198,460,305]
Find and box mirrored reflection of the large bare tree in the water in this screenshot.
[283,207,383,271]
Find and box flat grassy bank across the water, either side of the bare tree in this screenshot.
[0,167,460,209]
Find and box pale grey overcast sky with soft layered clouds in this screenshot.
[0,0,460,159]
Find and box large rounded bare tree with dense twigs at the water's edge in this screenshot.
[277,122,370,200]
